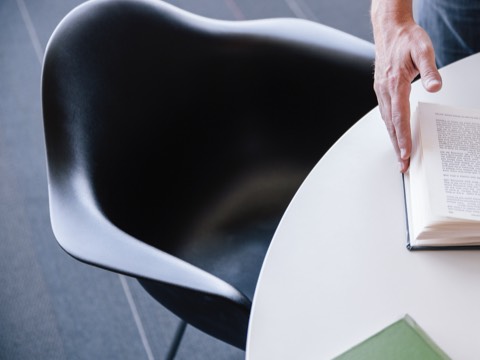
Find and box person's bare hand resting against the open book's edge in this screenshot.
[374,19,442,173]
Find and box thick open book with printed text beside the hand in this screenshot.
[403,102,480,250]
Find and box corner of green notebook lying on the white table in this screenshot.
[333,315,451,360]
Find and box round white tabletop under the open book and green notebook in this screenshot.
[246,54,480,360]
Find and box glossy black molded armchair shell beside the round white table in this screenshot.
[42,0,376,352]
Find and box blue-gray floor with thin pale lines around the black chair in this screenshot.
[0,0,372,360]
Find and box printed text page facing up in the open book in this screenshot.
[419,103,480,220]
